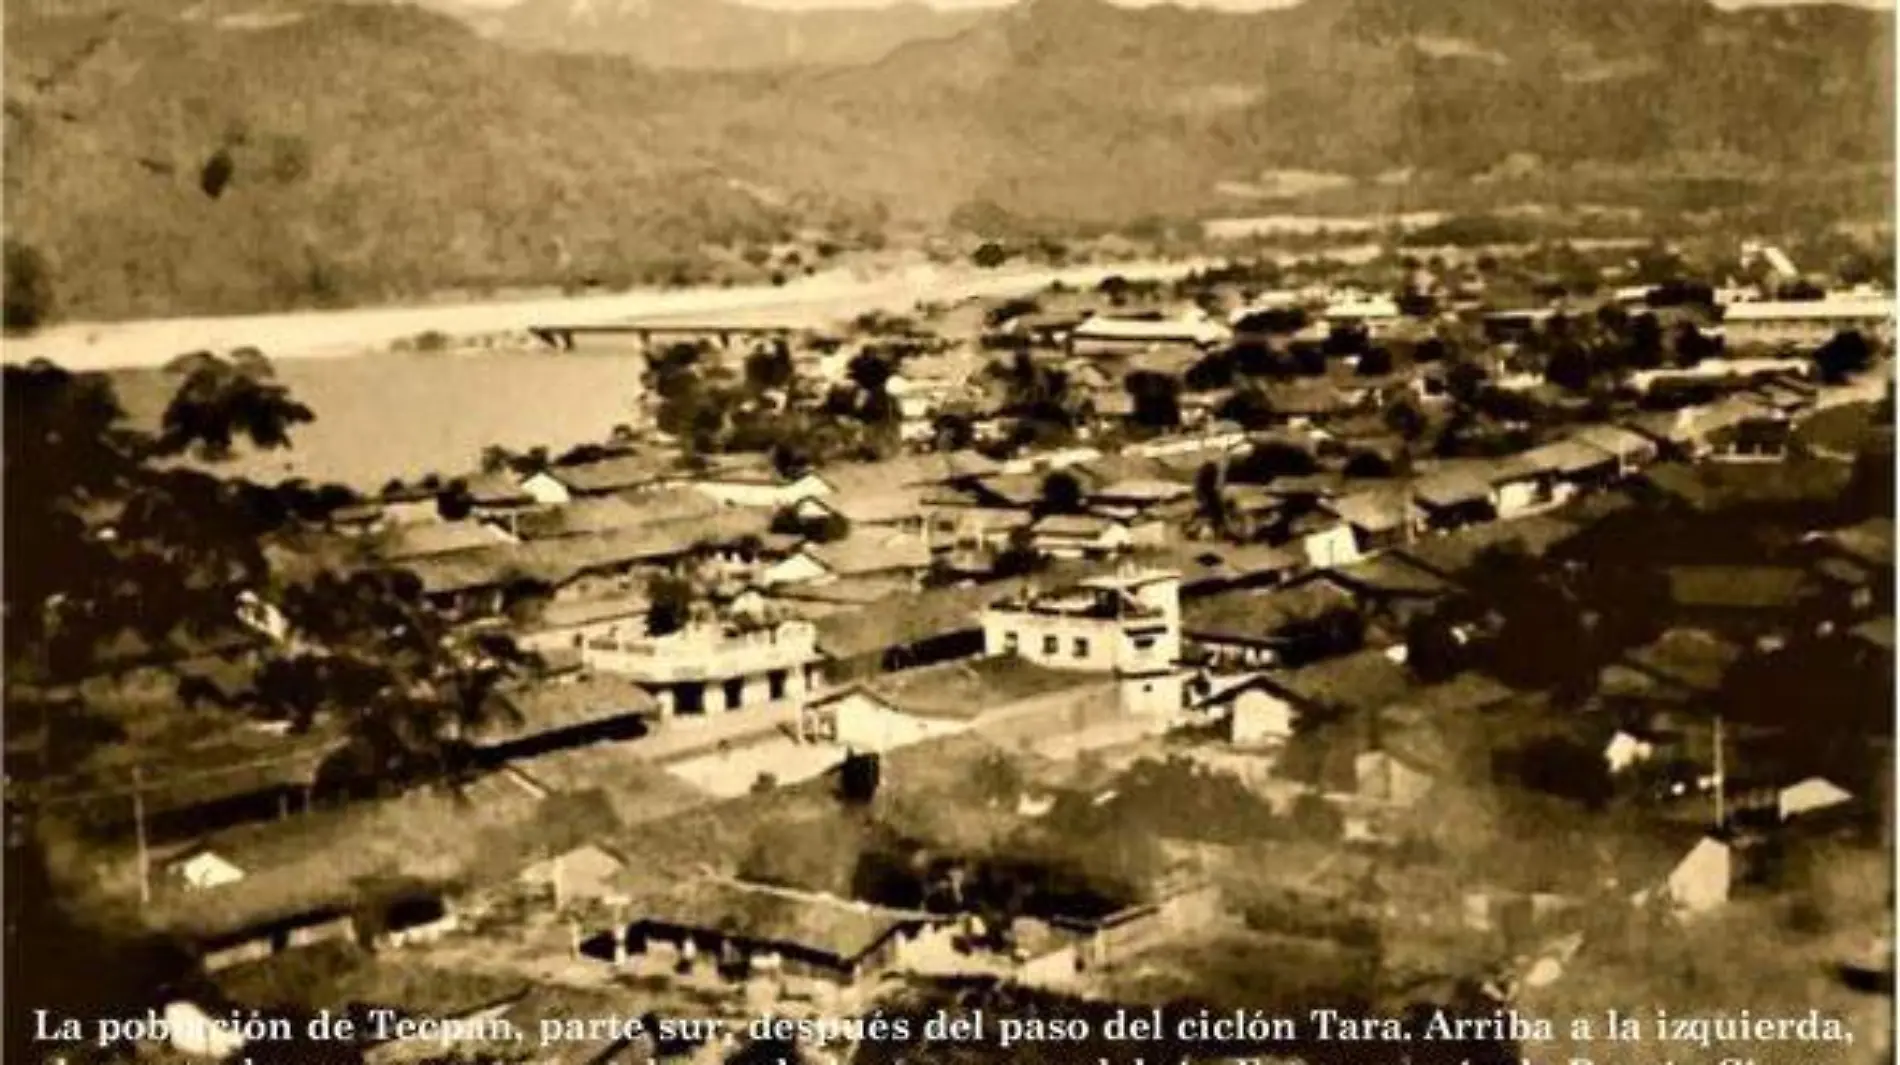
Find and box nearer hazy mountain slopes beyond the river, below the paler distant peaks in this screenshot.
[6,0,1894,315]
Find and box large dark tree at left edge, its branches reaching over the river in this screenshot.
[0,363,308,678]
